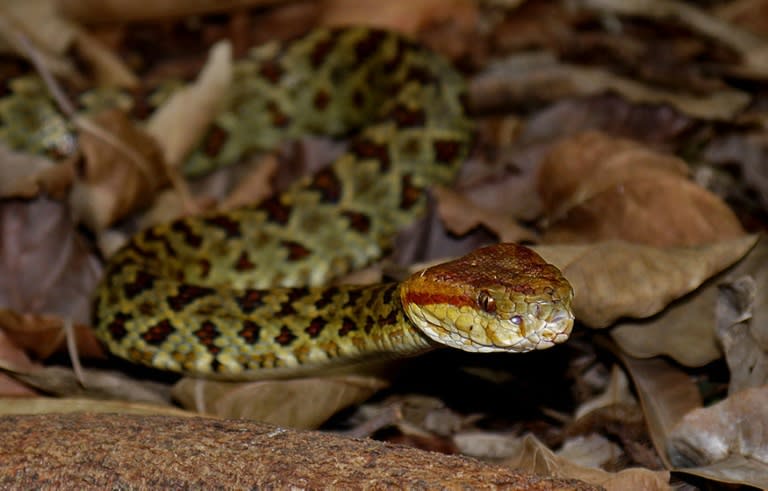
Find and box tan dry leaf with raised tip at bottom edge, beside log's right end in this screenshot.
[504,435,671,491]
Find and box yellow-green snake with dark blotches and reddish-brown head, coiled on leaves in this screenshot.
[3,28,573,380]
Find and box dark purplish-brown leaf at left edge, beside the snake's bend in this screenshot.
[0,199,101,358]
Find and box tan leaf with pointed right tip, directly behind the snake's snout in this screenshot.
[534,236,757,328]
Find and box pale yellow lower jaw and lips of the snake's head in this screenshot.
[407,304,574,353]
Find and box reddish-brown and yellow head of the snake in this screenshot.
[400,244,574,353]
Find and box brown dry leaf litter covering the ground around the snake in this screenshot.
[0,0,768,489]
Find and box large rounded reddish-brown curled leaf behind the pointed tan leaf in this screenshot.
[539,132,744,245]
